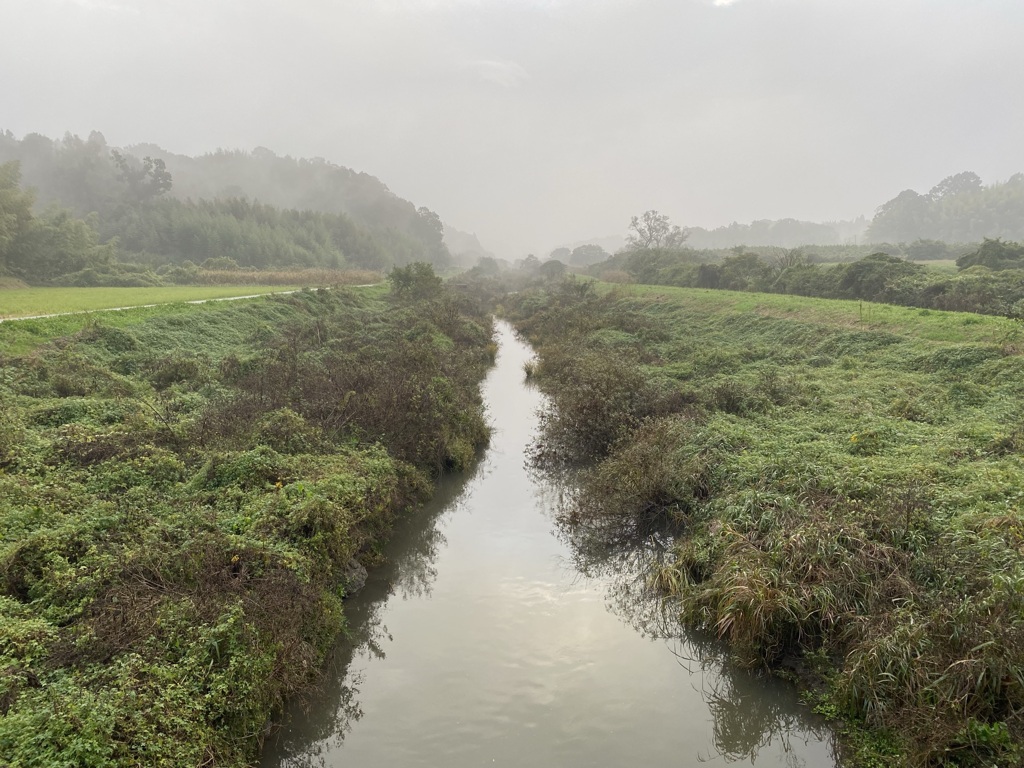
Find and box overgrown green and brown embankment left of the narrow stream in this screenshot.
[0,291,494,766]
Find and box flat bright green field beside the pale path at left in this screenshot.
[0,286,296,319]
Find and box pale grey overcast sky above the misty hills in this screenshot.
[0,0,1024,258]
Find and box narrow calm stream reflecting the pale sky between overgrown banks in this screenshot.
[262,325,835,768]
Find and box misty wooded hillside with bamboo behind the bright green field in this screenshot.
[0,132,451,285]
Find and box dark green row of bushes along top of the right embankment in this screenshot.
[590,240,1024,317]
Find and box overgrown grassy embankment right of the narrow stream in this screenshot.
[506,282,1024,766]
